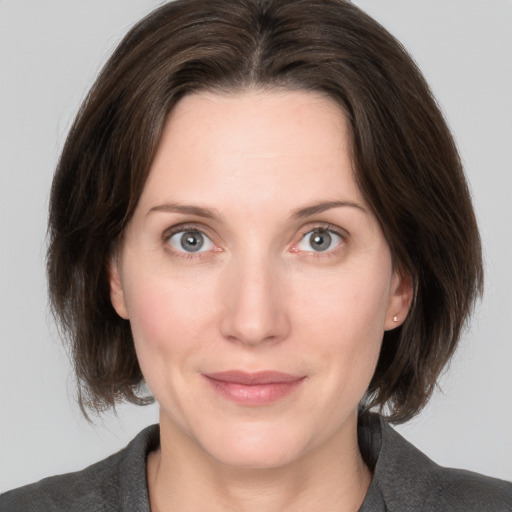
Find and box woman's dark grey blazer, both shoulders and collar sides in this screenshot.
[0,414,512,512]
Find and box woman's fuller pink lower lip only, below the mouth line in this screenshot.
[205,376,304,406]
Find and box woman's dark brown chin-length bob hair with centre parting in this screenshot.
[47,0,483,423]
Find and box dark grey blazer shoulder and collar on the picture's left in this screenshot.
[0,426,158,512]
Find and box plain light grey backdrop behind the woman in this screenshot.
[0,0,512,491]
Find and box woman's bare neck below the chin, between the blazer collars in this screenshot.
[148,412,371,512]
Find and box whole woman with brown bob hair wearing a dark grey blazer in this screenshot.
[0,0,512,511]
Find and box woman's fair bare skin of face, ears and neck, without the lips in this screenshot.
[110,91,411,512]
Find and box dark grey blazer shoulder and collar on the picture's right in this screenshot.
[360,418,512,512]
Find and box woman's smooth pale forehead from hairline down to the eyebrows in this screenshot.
[141,91,362,213]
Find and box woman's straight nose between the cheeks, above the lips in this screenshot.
[221,253,290,346]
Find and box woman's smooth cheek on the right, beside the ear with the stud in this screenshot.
[295,271,389,384]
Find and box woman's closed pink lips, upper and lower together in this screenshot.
[204,370,305,406]
